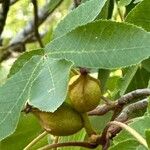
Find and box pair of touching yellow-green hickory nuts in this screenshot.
[31,69,101,136]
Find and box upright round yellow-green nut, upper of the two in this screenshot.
[69,74,101,112]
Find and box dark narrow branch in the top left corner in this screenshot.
[0,0,10,45]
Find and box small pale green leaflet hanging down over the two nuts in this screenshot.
[29,57,72,112]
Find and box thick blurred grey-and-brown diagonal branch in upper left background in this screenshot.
[0,0,63,62]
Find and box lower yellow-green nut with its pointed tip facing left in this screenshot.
[32,103,83,136]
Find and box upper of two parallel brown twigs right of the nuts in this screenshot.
[88,88,150,116]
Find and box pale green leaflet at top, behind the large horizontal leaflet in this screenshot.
[54,0,107,38]
